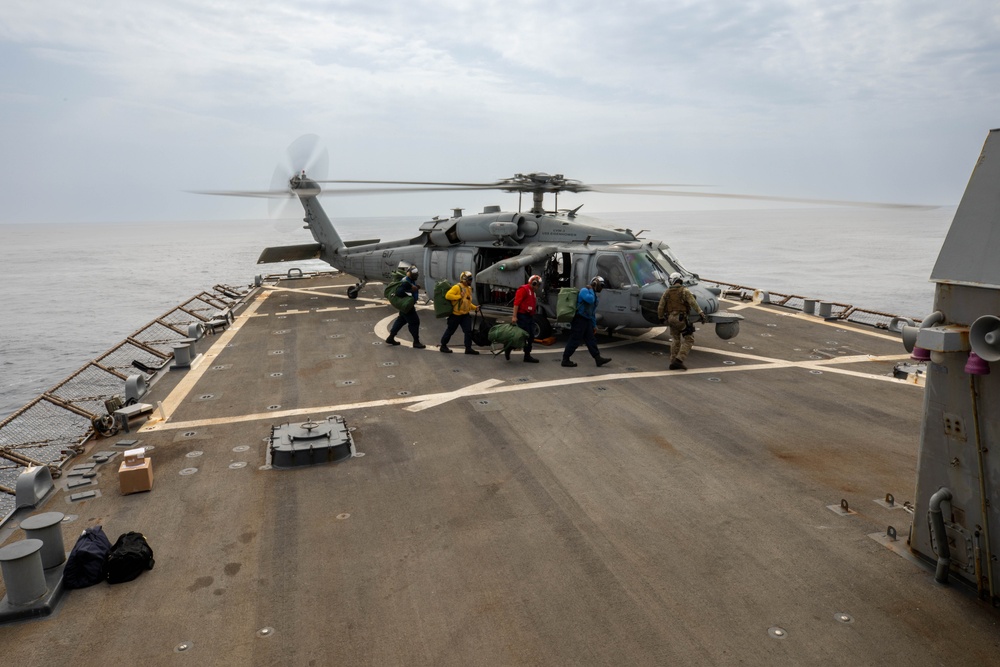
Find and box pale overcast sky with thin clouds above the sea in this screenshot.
[0,0,1000,222]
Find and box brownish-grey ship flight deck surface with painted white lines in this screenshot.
[0,276,1000,665]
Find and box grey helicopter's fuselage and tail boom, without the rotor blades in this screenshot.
[261,181,742,339]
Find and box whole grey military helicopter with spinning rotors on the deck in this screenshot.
[197,135,924,340]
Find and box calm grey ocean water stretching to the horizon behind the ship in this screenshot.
[0,207,954,419]
